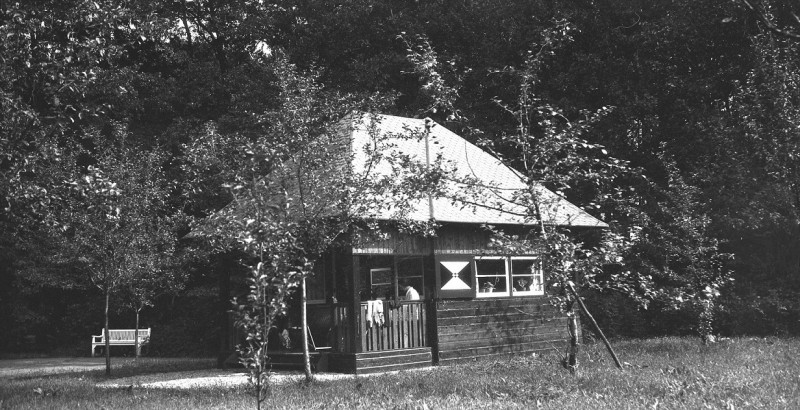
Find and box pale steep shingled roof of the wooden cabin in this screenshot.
[347,115,608,227]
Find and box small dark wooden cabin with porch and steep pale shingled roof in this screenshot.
[220,116,606,373]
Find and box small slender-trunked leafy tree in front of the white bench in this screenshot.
[40,131,176,372]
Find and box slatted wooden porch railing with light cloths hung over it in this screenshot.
[335,301,428,352]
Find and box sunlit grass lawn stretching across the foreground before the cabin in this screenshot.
[0,338,800,409]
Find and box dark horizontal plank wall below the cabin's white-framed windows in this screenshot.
[436,298,569,364]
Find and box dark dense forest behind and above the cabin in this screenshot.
[0,0,800,355]
